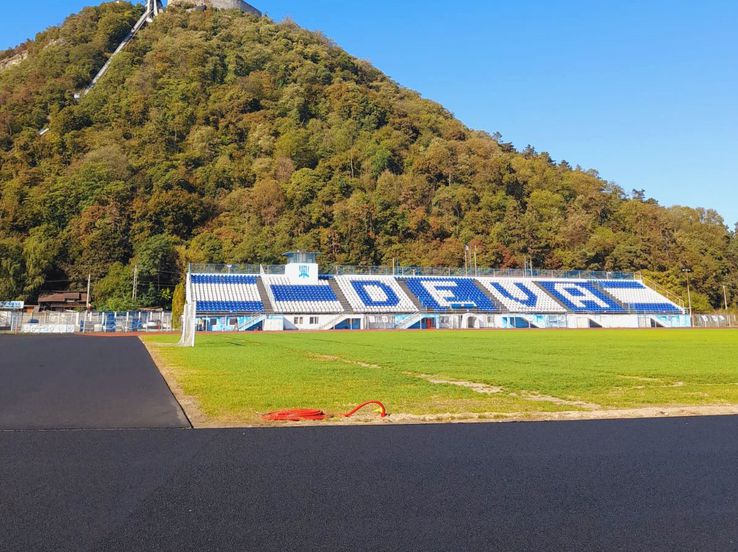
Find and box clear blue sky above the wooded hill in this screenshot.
[5,0,738,226]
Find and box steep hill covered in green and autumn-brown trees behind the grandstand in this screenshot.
[0,2,738,309]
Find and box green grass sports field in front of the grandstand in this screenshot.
[144,330,738,425]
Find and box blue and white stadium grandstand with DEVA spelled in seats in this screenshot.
[184,251,691,334]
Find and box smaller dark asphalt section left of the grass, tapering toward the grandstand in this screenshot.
[0,335,189,429]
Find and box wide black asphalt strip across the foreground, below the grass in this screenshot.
[0,417,738,552]
